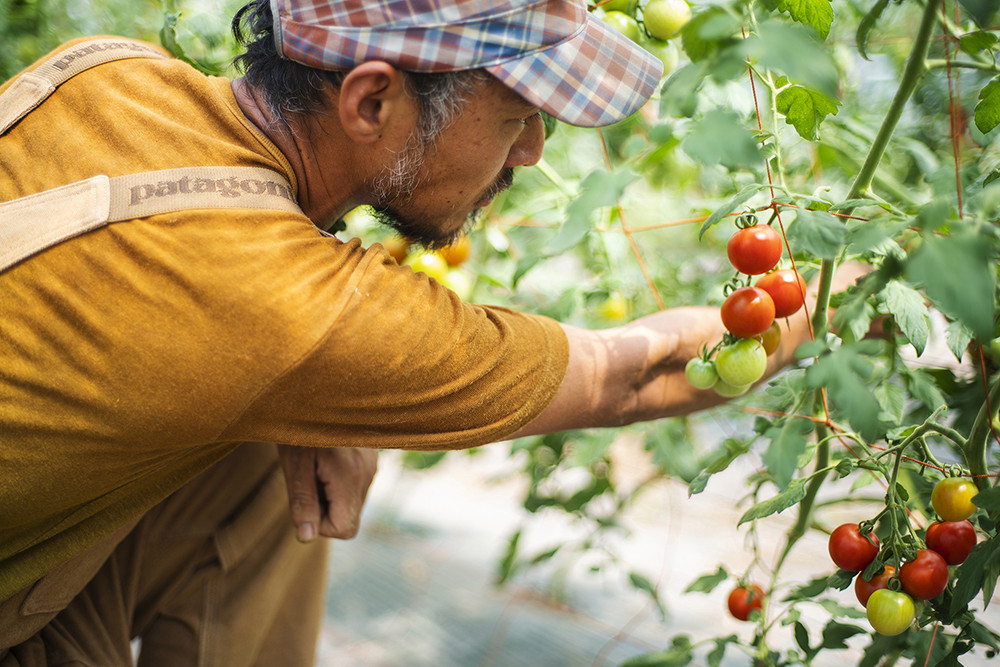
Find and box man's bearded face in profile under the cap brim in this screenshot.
[370,78,545,247]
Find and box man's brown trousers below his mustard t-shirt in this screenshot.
[0,444,327,667]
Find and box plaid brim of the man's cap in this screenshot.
[485,14,663,127]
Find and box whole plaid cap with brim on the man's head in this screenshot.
[271,0,663,127]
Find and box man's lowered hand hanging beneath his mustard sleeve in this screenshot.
[278,445,378,542]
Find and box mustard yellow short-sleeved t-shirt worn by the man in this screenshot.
[0,39,568,600]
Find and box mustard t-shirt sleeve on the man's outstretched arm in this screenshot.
[221,237,569,449]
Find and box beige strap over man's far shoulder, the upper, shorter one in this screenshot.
[0,38,168,136]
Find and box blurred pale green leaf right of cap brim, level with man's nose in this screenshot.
[681,109,764,170]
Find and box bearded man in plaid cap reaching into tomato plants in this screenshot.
[0,0,820,667]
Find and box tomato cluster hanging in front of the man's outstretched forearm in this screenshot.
[685,215,806,397]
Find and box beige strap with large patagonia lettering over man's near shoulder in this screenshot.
[0,167,302,272]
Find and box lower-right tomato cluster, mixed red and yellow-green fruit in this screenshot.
[827,477,977,636]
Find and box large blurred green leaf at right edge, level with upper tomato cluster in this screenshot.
[906,232,996,340]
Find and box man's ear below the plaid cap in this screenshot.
[338,60,415,143]
